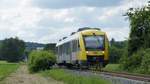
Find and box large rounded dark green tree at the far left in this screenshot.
[0,37,25,62]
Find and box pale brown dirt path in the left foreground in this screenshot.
[0,65,63,84]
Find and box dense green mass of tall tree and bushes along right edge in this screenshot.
[121,2,150,74]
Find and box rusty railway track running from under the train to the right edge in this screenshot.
[66,69,150,84]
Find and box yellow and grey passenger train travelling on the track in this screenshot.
[56,28,109,67]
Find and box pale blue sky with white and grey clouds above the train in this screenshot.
[0,0,148,43]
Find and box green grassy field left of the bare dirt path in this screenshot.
[0,61,19,80]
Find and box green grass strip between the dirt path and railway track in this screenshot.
[41,69,110,84]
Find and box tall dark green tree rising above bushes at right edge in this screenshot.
[127,6,150,56]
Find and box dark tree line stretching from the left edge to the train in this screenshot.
[0,37,55,62]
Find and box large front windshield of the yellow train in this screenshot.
[84,36,104,51]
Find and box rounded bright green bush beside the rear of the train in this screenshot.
[28,51,56,72]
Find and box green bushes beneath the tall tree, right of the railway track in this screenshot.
[121,48,150,74]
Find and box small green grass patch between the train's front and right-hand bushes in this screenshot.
[103,64,121,71]
